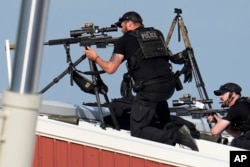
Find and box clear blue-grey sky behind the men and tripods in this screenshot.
[0,0,250,108]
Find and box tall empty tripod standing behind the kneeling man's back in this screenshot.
[165,8,212,109]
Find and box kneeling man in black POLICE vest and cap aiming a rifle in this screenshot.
[85,11,198,151]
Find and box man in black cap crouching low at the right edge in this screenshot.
[207,82,250,150]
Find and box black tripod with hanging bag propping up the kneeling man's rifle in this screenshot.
[39,44,120,130]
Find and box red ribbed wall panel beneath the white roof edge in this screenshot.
[33,135,173,167]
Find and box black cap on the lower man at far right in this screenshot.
[214,82,241,96]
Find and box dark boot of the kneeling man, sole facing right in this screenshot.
[174,125,199,151]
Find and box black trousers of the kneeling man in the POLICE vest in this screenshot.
[130,79,175,145]
